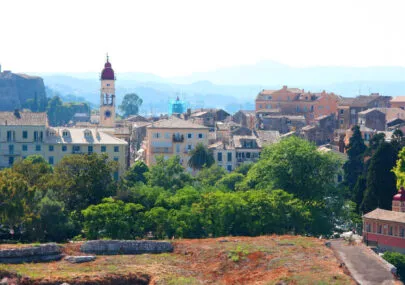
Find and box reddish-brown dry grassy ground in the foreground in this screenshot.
[0,235,354,285]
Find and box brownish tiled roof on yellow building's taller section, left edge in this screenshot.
[0,111,48,126]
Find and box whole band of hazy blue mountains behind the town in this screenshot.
[34,61,405,114]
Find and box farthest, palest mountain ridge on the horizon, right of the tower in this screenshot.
[170,61,405,86]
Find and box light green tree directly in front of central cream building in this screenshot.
[144,155,192,191]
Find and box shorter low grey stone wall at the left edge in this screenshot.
[0,243,63,263]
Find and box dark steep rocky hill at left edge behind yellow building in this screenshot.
[0,71,47,111]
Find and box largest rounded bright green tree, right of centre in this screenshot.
[243,137,342,201]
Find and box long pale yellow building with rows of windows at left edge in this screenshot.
[0,111,128,175]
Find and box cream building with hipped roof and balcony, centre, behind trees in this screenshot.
[145,117,209,171]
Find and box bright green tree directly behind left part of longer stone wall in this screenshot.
[82,198,143,239]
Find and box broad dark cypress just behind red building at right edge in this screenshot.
[360,142,397,213]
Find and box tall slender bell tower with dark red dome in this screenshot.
[100,54,115,128]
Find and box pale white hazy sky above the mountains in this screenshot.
[0,0,405,76]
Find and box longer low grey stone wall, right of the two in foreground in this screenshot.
[80,240,173,255]
